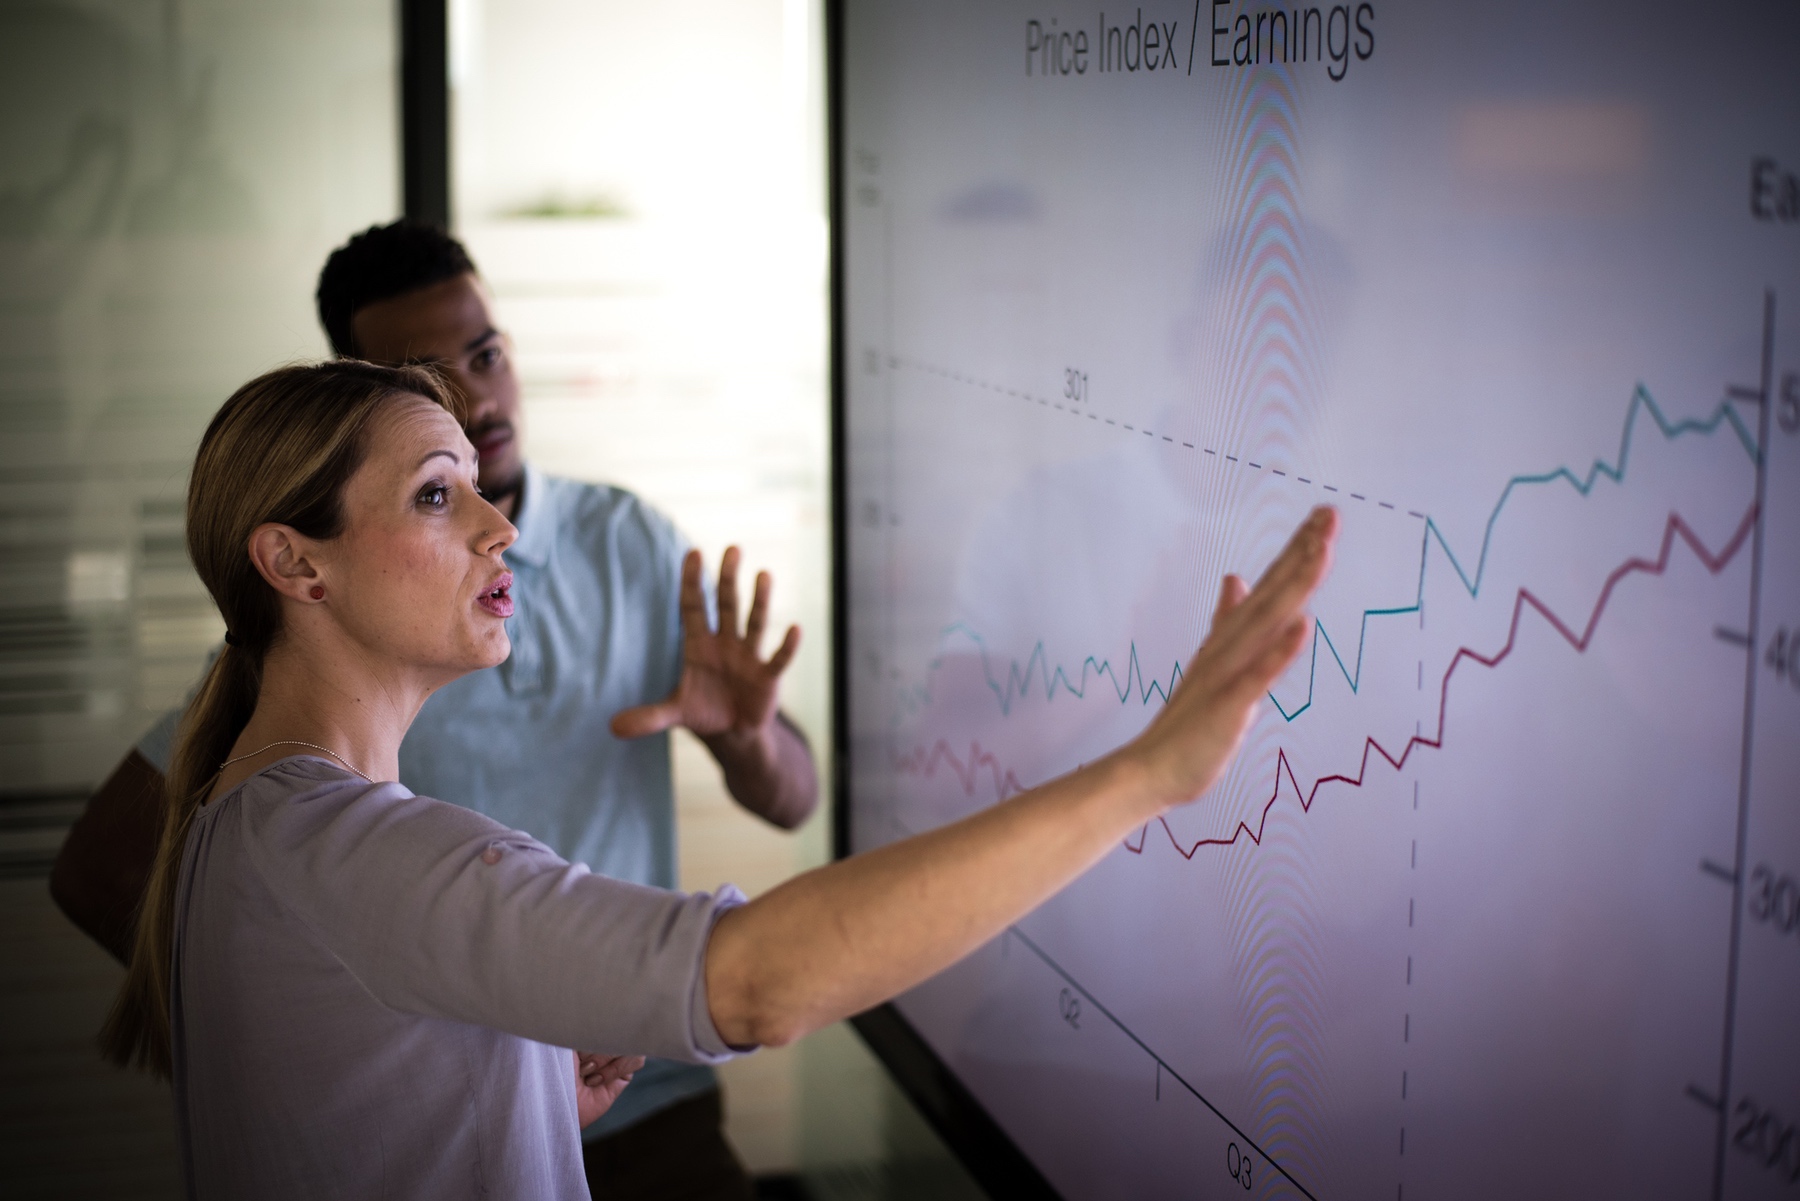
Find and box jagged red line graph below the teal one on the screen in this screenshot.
[895,504,1757,859]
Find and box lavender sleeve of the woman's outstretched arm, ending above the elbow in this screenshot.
[243,760,747,1062]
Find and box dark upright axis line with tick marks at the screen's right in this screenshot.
[1712,288,1775,1201]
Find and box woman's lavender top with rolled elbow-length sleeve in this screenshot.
[171,756,743,1199]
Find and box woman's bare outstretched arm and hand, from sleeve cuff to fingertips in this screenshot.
[706,508,1337,1046]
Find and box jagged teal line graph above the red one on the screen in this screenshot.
[902,384,1759,722]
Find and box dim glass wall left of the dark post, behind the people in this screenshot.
[0,0,398,1197]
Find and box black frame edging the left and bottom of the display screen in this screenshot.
[824,0,1060,1199]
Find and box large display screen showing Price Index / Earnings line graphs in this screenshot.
[832,0,1800,1201]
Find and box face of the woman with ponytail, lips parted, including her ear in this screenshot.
[320,396,518,686]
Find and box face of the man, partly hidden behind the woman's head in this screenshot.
[349,275,524,501]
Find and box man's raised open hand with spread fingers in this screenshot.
[612,546,799,738]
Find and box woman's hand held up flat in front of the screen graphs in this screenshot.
[1120,506,1337,817]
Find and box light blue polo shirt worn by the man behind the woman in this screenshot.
[137,466,716,1138]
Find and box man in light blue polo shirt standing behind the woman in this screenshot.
[50,221,817,1199]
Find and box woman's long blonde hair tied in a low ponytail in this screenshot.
[101,360,461,1077]
